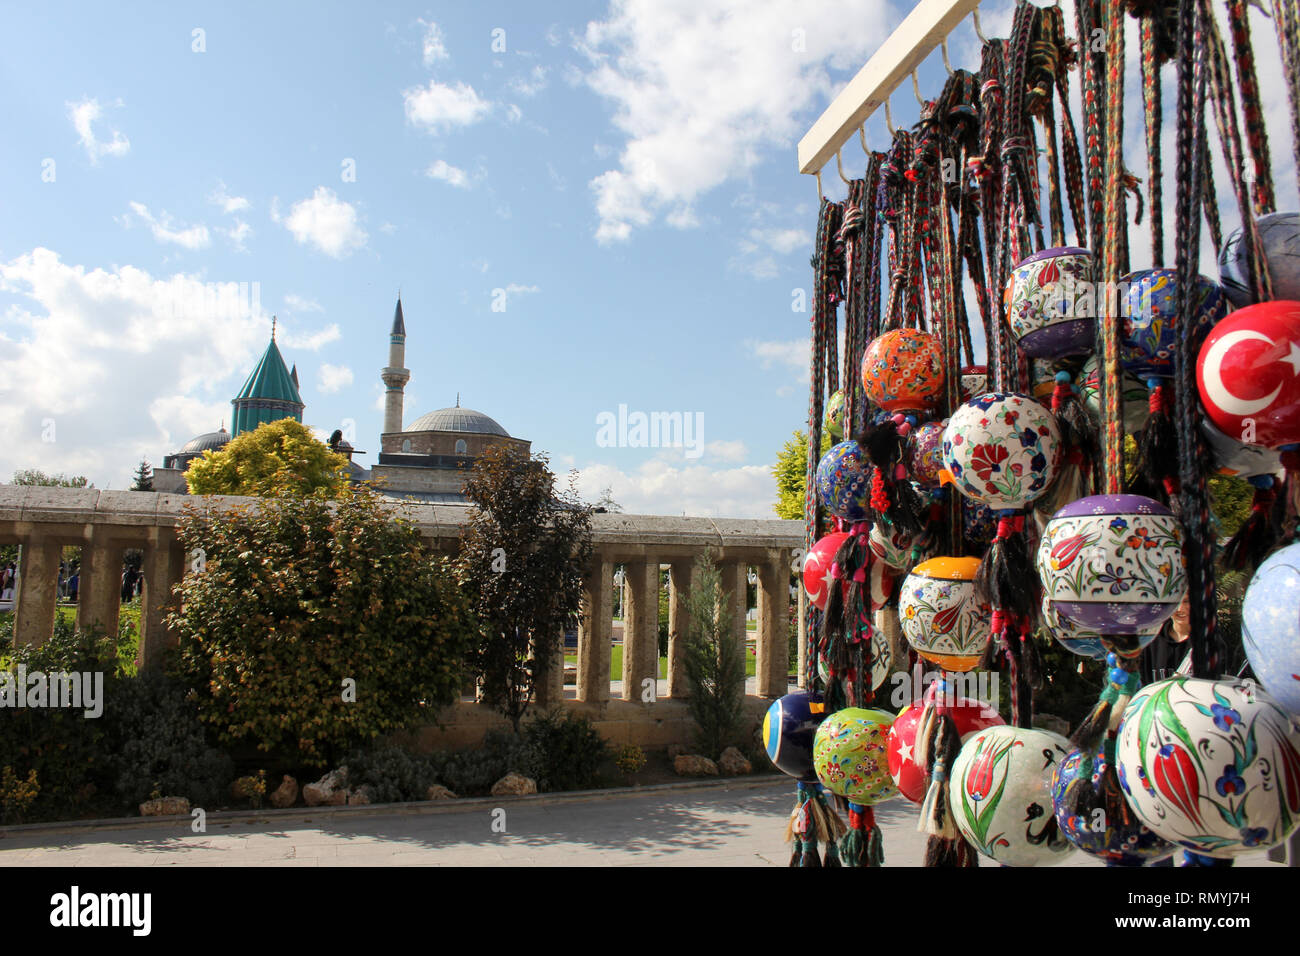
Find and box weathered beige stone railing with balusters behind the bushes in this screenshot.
[0,485,803,745]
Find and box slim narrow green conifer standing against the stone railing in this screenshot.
[685,549,745,758]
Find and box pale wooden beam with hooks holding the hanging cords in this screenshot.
[800,0,979,174]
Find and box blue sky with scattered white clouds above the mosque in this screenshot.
[0,0,1295,516]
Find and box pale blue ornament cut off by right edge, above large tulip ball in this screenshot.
[1242,544,1300,715]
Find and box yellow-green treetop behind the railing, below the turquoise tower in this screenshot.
[185,419,347,498]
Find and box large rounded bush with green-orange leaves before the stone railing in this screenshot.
[169,490,476,765]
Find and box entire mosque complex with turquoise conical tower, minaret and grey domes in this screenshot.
[153,297,532,503]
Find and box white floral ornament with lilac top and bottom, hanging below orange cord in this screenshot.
[1035,494,1187,635]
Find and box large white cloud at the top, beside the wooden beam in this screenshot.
[579,0,894,242]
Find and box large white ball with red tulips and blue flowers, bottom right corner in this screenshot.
[1115,676,1300,857]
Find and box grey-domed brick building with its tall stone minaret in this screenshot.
[369,298,532,505]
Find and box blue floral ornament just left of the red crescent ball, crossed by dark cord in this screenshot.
[1119,269,1229,382]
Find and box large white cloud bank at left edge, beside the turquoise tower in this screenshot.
[0,248,270,488]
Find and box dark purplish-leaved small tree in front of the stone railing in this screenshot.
[456,445,592,734]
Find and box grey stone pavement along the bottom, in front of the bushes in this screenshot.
[0,778,1275,866]
